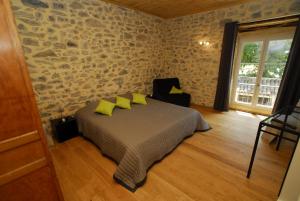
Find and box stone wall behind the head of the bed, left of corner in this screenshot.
[11,0,163,137]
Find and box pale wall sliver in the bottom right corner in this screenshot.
[278,143,300,201]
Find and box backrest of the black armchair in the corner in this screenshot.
[153,78,180,96]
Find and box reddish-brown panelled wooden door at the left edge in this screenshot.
[0,0,63,201]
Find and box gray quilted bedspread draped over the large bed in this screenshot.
[76,98,210,191]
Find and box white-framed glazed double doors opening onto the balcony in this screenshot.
[230,27,295,114]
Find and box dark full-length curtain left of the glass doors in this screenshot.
[214,22,238,111]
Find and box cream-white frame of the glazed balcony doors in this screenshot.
[229,27,296,115]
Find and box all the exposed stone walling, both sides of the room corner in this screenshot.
[11,0,300,140]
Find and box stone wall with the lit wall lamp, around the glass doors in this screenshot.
[161,0,300,107]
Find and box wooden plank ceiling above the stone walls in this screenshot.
[104,0,253,18]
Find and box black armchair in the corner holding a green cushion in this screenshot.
[152,78,191,107]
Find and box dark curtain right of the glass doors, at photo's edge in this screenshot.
[273,19,300,113]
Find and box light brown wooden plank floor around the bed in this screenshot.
[51,107,291,201]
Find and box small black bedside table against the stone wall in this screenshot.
[50,116,79,142]
